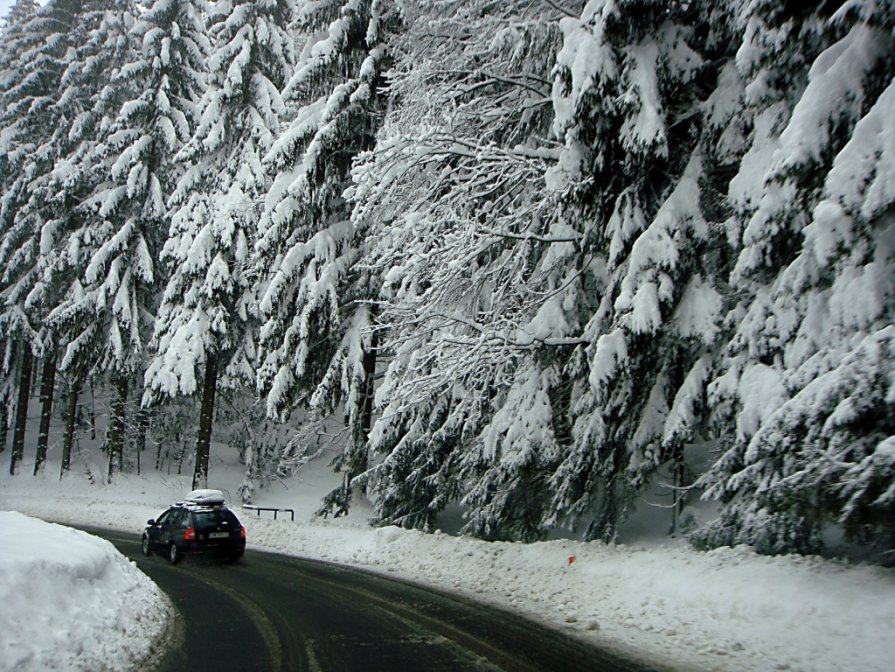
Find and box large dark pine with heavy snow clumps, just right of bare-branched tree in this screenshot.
[547,0,730,540]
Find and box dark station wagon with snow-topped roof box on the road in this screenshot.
[143,490,246,565]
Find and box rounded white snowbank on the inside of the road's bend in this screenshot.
[0,511,171,672]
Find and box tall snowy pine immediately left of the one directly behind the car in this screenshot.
[50,0,210,477]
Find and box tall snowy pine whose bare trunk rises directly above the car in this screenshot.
[143,0,295,487]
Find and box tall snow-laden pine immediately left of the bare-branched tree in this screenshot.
[253,0,400,513]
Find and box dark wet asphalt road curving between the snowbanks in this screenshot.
[98,529,659,672]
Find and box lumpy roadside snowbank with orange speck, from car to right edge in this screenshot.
[244,517,895,672]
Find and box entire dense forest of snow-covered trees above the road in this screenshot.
[0,0,895,559]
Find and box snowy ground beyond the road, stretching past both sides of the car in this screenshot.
[0,446,895,672]
